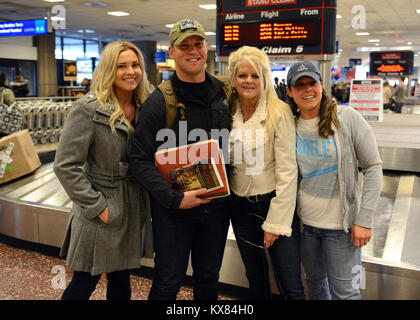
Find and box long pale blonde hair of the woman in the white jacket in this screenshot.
[228,46,290,132]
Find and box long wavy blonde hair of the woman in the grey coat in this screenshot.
[91,41,150,134]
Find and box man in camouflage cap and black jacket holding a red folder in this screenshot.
[130,19,230,300]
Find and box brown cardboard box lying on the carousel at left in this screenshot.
[0,129,41,184]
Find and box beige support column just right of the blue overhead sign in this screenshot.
[34,32,57,97]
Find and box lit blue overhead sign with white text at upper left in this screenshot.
[0,19,47,37]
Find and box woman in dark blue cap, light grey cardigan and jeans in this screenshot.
[287,62,382,299]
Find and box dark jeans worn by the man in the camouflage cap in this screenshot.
[149,203,229,300]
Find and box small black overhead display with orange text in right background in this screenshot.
[370,51,414,76]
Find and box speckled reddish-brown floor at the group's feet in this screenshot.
[0,242,233,300]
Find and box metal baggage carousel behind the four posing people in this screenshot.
[0,109,420,299]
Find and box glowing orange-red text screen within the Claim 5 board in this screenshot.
[223,20,320,45]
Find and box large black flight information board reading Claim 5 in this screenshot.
[217,0,336,57]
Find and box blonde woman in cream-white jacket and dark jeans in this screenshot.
[228,46,305,299]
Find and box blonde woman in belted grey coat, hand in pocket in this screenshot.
[54,42,150,300]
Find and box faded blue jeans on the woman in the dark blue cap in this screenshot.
[301,225,361,300]
